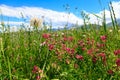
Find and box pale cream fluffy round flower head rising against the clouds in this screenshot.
[30,17,42,28]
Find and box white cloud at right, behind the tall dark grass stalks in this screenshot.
[85,1,120,24]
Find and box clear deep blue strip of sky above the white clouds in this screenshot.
[0,0,119,13]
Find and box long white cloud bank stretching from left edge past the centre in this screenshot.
[0,5,83,26]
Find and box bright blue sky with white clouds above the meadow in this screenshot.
[0,0,120,28]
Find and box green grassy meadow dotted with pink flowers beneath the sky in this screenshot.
[0,1,120,80]
